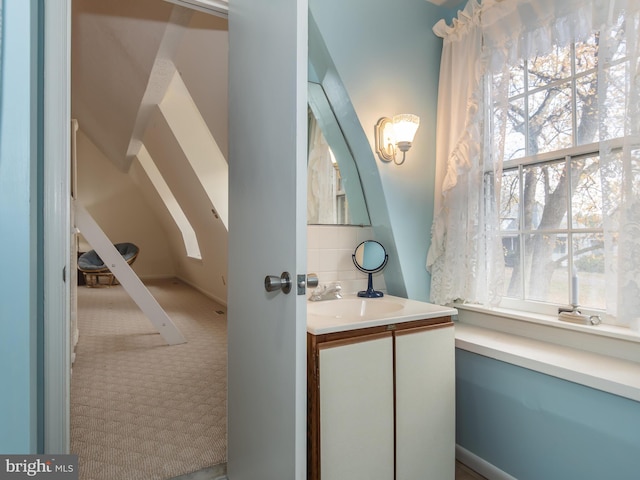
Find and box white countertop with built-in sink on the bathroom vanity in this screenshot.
[307,294,458,335]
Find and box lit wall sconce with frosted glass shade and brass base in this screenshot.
[376,113,420,165]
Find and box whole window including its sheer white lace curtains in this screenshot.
[427,0,640,331]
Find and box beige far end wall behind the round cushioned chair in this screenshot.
[77,125,176,278]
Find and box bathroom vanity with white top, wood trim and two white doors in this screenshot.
[307,296,457,480]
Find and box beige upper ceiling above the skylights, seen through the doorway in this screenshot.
[71,0,228,171]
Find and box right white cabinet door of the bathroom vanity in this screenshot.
[396,326,455,480]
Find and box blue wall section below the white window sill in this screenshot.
[456,349,640,480]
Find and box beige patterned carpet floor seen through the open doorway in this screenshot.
[71,280,227,480]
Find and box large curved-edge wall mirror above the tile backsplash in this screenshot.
[307,82,371,225]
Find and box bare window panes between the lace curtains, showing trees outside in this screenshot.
[485,26,628,318]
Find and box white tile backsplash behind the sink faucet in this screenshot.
[307,225,386,293]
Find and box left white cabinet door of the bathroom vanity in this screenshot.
[319,333,394,480]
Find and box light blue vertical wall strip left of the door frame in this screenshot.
[0,0,42,454]
